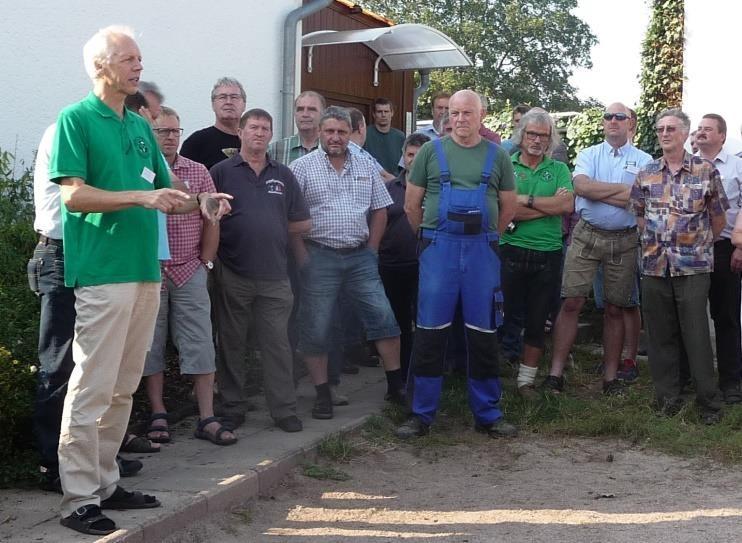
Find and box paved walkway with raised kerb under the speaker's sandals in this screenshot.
[0,367,386,543]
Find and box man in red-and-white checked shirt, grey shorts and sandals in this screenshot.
[144,107,237,445]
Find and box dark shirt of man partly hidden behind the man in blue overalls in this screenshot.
[379,171,417,268]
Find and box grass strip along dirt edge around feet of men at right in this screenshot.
[378,346,742,463]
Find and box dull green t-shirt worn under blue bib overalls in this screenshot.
[409,136,515,232]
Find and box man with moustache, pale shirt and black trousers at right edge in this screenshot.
[696,113,742,404]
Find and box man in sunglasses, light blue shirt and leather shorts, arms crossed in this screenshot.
[544,103,652,394]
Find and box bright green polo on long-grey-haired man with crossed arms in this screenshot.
[500,151,572,251]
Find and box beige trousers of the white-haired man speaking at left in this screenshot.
[58,283,160,517]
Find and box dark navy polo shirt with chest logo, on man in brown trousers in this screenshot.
[211,154,310,281]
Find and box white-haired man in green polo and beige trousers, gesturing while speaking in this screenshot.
[49,27,229,535]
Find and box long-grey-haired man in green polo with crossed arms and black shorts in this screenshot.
[500,108,574,397]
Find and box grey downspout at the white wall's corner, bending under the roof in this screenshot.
[281,0,333,138]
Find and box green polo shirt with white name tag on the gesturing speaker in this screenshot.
[49,93,170,287]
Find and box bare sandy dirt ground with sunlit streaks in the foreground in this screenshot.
[163,432,742,543]
